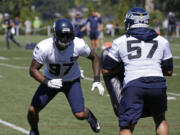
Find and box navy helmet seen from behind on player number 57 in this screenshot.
[124,7,150,30]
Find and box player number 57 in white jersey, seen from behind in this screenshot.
[102,7,173,135]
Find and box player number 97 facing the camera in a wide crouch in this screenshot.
[28,19,104,135]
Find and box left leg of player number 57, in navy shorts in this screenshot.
[119,86,144,135]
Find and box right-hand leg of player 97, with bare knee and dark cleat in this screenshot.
[63,79,100,132]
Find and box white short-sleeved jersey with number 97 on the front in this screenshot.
[33,38,91,81]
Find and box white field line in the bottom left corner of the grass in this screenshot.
[0,119,29,135]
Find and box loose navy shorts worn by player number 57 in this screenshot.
[119,86,167,127]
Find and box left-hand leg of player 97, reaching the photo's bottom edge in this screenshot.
[27,84,59,135]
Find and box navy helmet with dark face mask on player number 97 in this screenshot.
[54,18,74,48]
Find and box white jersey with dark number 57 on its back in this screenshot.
[108,35,172,87]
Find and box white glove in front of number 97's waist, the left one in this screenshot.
[47,79,62,89]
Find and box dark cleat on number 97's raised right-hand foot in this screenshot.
[87,110,101,133]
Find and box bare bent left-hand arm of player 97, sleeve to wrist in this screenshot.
[29,59,46,83]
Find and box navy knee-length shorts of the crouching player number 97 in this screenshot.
[31,79,84,113]
